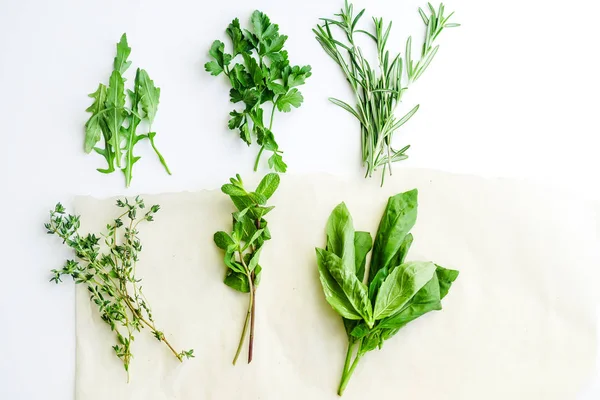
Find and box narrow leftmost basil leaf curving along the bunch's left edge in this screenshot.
[316,249,362,320]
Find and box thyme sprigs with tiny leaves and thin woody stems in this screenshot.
[44,197,194,382]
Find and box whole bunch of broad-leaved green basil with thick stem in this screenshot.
[316,189,458,396]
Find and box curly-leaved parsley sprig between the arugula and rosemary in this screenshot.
[204,11,311,172]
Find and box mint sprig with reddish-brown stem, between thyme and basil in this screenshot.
[214,173,279,365]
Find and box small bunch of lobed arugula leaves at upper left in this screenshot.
[84,34,171,187]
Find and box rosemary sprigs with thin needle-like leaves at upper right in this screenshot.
[313,0,459,185]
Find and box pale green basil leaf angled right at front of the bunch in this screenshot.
[373,261,436,320]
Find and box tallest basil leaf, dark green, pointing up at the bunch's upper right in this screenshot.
[369,189,418,282]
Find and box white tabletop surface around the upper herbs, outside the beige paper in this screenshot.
[0,0,600,400]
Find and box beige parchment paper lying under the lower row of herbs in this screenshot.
[76,169,599,400]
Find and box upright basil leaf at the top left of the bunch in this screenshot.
[325,203,356,275]
